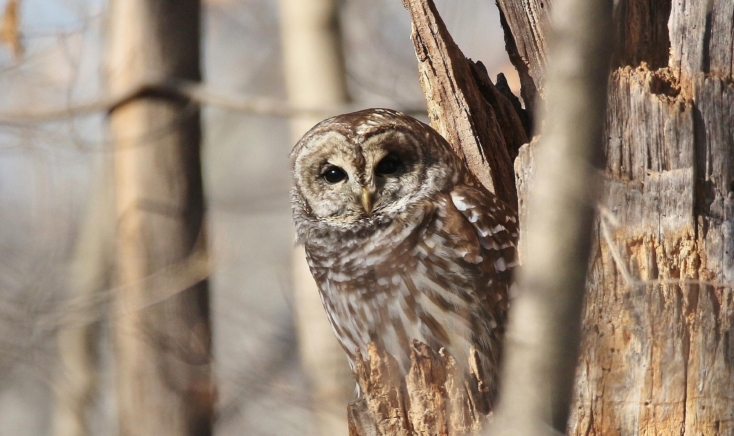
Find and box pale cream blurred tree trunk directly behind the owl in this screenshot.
[280,0,354,435]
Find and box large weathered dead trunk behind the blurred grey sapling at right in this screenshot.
[499,0,734,436]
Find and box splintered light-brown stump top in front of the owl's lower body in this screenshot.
[348,340,491,436]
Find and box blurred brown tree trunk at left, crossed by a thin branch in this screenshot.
[109,0,214,436]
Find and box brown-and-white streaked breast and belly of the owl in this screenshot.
[306,190,514,378]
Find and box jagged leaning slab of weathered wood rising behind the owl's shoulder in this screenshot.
[403,0,529,206]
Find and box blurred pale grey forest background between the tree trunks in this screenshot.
[0,0,519,436]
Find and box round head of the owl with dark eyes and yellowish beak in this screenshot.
[291,109,462,237]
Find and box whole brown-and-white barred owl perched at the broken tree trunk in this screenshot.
[291,109,517,402]
